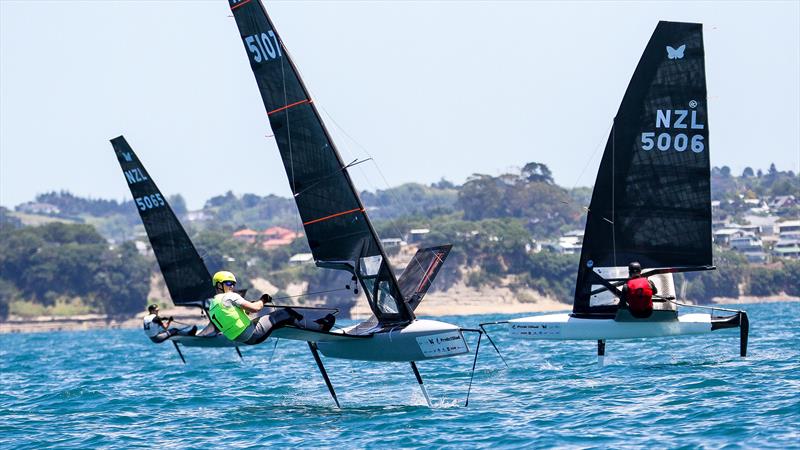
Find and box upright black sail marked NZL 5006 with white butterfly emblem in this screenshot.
[573,22,712,313]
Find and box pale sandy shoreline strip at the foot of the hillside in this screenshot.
[0,294,800,334]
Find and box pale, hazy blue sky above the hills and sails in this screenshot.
[0,0,800,209]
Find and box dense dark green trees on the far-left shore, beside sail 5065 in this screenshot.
[0,222,153,318]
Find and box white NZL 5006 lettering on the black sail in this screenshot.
[640,100,706,153]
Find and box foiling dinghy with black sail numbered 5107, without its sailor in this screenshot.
[229,0,480,406]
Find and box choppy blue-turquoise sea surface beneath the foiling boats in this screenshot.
[0,303,800,449]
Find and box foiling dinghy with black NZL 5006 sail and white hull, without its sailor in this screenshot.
[482,22,749,360]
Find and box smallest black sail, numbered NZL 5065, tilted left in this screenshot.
[111,136,214,307]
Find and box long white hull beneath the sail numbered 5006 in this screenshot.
[508,313,712,341]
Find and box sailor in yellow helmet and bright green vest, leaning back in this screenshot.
[208,270,303,345]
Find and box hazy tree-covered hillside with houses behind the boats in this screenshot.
[0,163,800,317]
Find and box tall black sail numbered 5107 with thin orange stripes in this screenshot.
[229,0,413,322]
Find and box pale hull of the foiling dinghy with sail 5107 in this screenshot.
[317,320,469,362]
